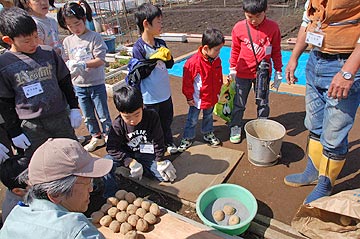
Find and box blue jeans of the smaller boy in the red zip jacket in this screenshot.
[183,106,214,139]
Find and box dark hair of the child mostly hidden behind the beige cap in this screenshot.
[0,155,30,190]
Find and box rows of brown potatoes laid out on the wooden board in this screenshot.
[91,190,160,235]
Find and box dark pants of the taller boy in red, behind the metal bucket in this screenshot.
[229,77,270,127]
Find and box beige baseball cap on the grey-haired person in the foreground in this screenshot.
[29,138,113,185]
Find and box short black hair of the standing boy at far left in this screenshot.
[0,7,37,39]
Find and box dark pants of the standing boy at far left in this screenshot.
[21,110,77,158]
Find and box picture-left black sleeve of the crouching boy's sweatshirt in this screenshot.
[106,116,133,164]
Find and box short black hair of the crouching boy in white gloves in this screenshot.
[113,85,143,113]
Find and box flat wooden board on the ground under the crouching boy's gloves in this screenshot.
[117,141,244,203]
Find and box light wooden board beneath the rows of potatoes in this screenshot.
[96,209,239,239]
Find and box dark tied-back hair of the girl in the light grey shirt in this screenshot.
[57,0,92,30]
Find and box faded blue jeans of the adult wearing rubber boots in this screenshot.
[305,51,360,157]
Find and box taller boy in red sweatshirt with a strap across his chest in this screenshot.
[229,0,282,144]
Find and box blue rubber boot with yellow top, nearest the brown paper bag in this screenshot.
[304,155,345,204]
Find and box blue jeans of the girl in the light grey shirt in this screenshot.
[74,84,111,136]
